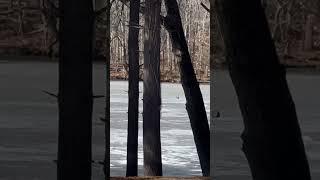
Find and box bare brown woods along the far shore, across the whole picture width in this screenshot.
[0,0,320,82]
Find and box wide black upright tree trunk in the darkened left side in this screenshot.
[57,0,94,180]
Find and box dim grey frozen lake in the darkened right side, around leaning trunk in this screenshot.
[214,70,320,180]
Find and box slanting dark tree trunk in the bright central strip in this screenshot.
[164,0,210,176]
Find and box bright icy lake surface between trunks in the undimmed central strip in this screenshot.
[110,81,210,176]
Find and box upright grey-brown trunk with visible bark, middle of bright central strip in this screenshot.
[143,0,162,176]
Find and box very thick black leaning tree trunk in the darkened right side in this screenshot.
[215,0,310,180]
